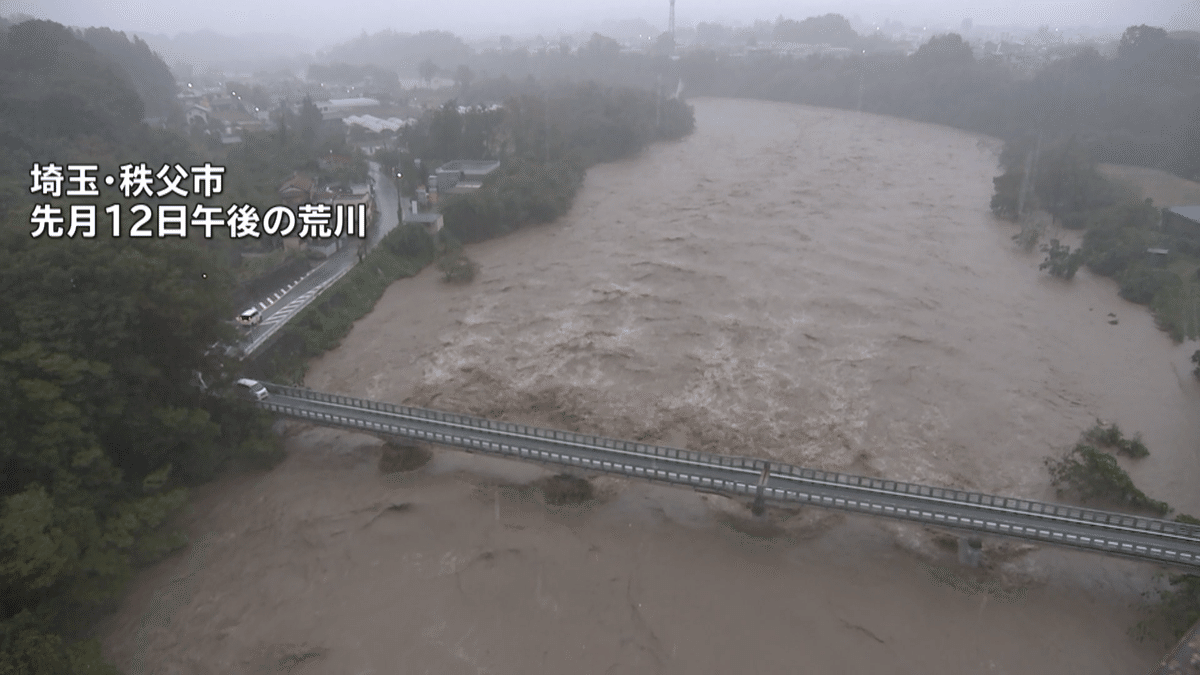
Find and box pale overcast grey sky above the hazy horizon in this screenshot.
[0,0,1200,46]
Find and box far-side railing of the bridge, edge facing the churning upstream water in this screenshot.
[263,382,1200,542]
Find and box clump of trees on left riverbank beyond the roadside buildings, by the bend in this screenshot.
[401,79,695,243]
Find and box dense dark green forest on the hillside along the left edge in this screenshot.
[0,22,278,675]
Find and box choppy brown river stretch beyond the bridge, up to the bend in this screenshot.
[307,101,1200,512]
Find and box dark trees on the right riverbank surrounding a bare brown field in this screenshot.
[991,26,1200,341]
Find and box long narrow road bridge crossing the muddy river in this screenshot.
[258,382,1200,573]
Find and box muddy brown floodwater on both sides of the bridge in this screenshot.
[106,100,1200,675]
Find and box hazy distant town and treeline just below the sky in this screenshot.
[154,14,1185,154]
